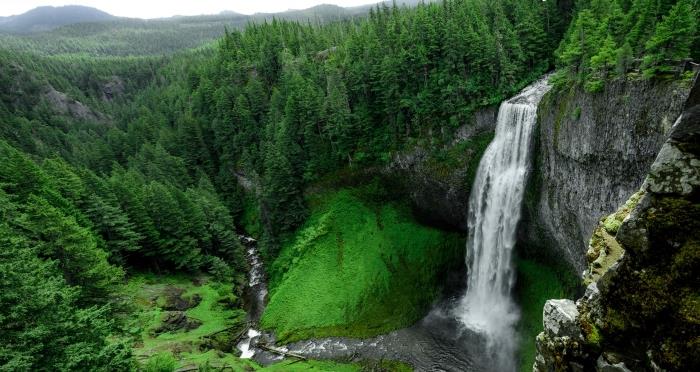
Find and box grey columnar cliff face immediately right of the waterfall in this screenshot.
[520,81,689,273]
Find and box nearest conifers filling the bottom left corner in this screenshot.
[0,198,135,371]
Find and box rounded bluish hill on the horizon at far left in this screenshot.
[0,5,119,33]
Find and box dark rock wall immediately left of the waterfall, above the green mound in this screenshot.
[383,106,498,230]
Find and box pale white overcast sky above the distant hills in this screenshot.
[0,0,379,18]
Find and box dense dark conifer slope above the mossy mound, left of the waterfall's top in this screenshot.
[190,0,566,253]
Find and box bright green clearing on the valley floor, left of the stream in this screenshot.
[120,274,372,372]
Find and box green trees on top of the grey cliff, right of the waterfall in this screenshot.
[556,0,700,92]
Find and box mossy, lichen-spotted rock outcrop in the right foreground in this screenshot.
[534,75,700,371]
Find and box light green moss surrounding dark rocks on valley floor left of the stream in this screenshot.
[122,274,361,372]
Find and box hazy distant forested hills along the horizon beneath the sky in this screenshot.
[0,0,426,57]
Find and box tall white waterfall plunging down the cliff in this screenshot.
[455,78,549,371]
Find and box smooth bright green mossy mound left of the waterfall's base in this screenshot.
[262,188,463,341]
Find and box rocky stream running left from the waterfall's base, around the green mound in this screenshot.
[237,240,495,372]
